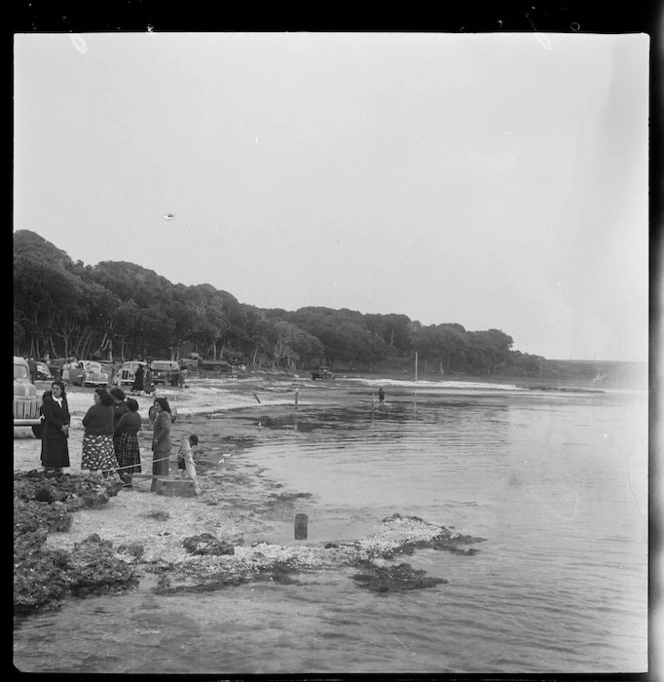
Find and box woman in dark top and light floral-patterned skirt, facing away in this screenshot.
[81,388,118,478]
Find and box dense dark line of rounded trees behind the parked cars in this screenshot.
[13,230,544,374]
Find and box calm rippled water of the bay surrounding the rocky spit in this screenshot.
[14,388,648,674]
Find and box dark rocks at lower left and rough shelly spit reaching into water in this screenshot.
[14,470,482,614]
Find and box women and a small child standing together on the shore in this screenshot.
[41,379,200,493]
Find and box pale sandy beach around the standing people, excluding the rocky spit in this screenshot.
[14,375,356,562]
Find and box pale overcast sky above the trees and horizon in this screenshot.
[13,33,650,361]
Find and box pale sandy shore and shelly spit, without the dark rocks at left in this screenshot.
[14,375,632,610]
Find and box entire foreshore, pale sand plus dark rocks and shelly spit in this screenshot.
[14,374,482,614]
